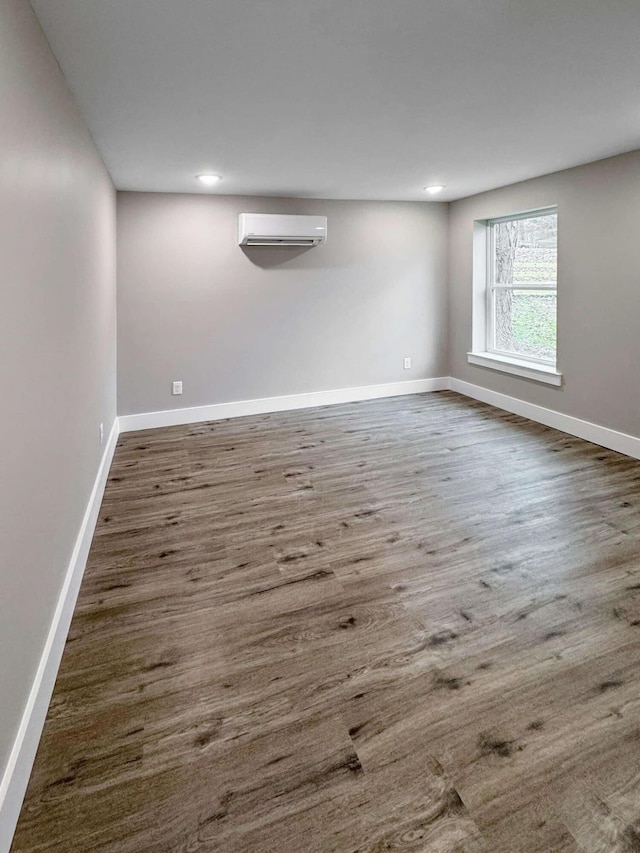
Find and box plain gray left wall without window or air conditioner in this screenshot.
[0,0,116,776]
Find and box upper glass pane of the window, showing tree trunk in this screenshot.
[493,213,558,284]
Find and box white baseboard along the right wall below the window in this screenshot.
[449,377,640,459]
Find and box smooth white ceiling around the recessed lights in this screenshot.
[32,0,640,201]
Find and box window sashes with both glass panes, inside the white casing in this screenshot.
[486,209,558,368]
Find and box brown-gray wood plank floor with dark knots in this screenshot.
[12,392,640,853]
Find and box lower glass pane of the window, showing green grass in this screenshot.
[494,290,557,362]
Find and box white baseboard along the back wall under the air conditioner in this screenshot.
[119,376,449,432]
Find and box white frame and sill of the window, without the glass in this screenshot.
[467,205,562,385]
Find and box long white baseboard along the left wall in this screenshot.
[0,418,119,853]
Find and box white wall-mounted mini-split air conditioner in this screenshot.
[238,213,327,246]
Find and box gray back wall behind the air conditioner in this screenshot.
[118,192,447,415]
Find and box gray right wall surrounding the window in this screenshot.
[449,152,640,436]
